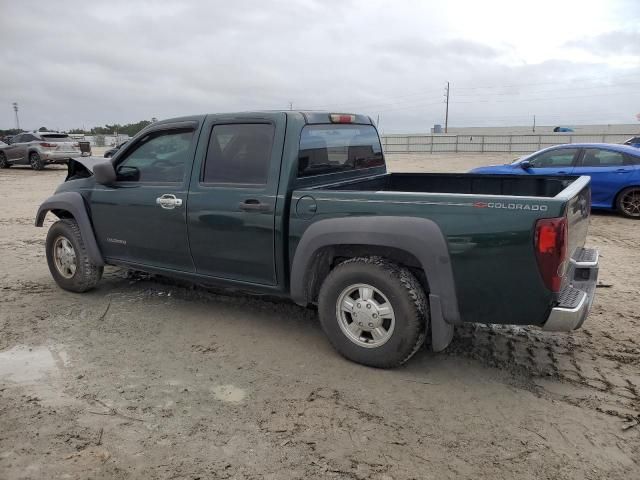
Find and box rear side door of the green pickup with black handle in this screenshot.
[188,113,286,285]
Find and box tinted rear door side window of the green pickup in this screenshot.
[202,123,275,186]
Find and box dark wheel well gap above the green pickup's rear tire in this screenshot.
[305,245,429,303]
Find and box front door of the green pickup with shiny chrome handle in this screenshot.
[90,121,199,272]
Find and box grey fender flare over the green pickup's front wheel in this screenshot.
[36,192,104,266]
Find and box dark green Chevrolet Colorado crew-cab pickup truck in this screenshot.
[36,111,598,367]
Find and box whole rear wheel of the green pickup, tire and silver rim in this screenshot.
[318,257,429,368]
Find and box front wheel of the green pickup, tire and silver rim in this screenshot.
[46,218,103,293]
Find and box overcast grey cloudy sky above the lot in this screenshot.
[0,0,640,133]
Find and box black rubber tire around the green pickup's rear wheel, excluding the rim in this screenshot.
[318,257,429,368]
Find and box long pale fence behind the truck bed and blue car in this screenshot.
[382,133,629,153]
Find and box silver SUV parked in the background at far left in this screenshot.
[0,132,81,170]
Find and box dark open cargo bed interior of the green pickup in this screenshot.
[323,173,578,198]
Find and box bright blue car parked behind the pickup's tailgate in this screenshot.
[470,143,640,219]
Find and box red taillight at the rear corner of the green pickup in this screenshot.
[535,217,567,292]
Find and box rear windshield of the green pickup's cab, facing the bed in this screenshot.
[298,125,384,177]
